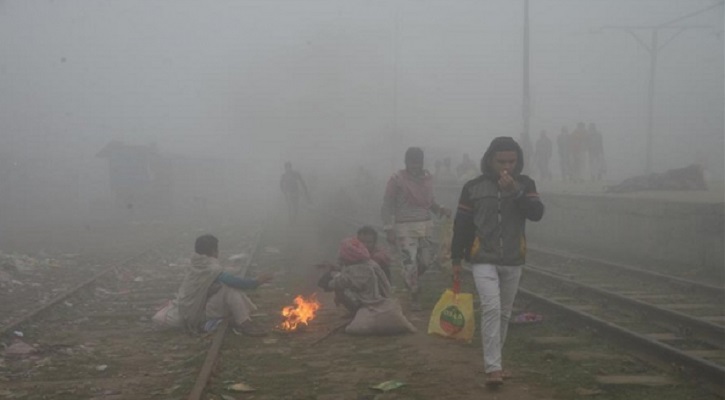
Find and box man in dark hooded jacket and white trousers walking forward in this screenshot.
[451,137,544,387]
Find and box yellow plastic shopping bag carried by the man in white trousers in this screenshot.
[428,274,476,342]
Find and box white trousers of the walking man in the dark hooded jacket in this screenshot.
[472,264,522,373]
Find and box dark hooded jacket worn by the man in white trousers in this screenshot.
[451,137,544,265]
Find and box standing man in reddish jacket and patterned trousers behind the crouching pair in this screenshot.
[381,147,451,311]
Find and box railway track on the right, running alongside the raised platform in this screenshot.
[520,249,725,393]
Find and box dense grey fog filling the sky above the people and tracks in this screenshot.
[0,0,725,238]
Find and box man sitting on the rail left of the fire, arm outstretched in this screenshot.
[176,234,272,336]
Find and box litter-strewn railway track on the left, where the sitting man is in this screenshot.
[0,223,261,399]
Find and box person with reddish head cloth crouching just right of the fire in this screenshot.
[318,237,391,315]
